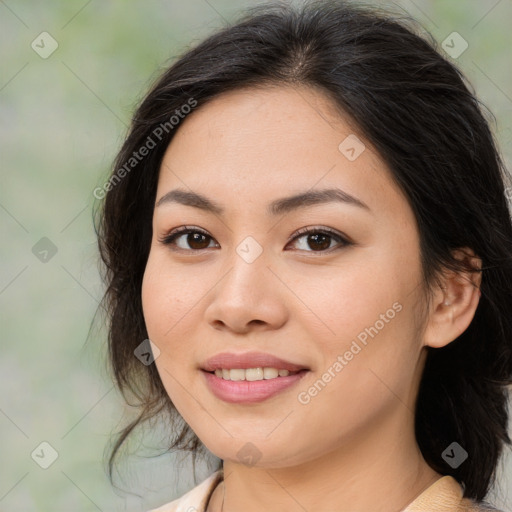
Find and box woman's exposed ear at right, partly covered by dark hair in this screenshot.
[423,247,482,348]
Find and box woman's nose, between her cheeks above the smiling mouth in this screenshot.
[205,245,290,334]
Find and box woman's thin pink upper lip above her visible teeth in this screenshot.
[201,352,308,372]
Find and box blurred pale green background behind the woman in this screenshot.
[0,0,512,512]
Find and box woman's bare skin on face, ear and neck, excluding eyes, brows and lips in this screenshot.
[142,86,479,512]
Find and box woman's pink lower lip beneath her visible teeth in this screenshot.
[202,370,309,404]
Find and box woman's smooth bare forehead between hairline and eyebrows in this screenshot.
[157,86,406,220]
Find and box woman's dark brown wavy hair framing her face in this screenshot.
[97,1,512,500]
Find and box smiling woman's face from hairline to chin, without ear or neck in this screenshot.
[142,87,424,467]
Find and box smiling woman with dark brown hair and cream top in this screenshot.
[94,1,512,512]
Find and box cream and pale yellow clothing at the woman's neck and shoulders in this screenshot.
[148,470,500,512]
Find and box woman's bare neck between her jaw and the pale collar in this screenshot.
[208,415,441,512]
